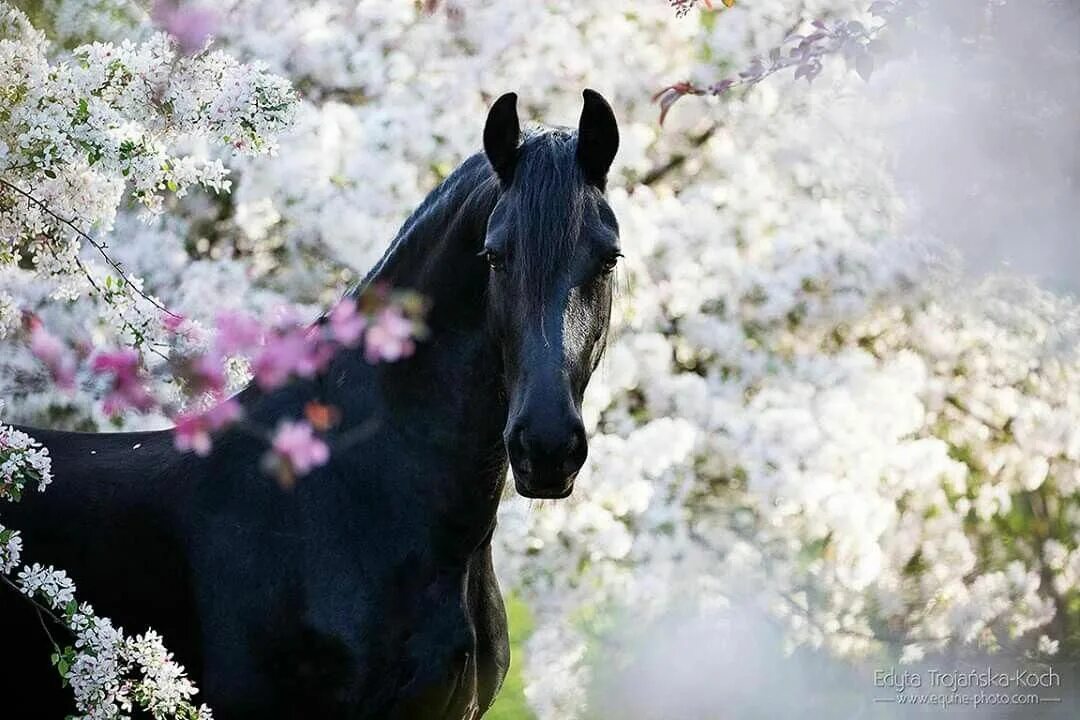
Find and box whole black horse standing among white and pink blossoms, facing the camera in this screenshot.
[0,90,619,720]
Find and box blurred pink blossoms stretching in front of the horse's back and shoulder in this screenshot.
[25,287,426,479]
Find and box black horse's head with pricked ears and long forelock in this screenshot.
[481,90,620,498]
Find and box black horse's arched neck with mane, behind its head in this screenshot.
[341,155,507,465]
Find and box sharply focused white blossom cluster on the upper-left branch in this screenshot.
[0,3,296,338]
